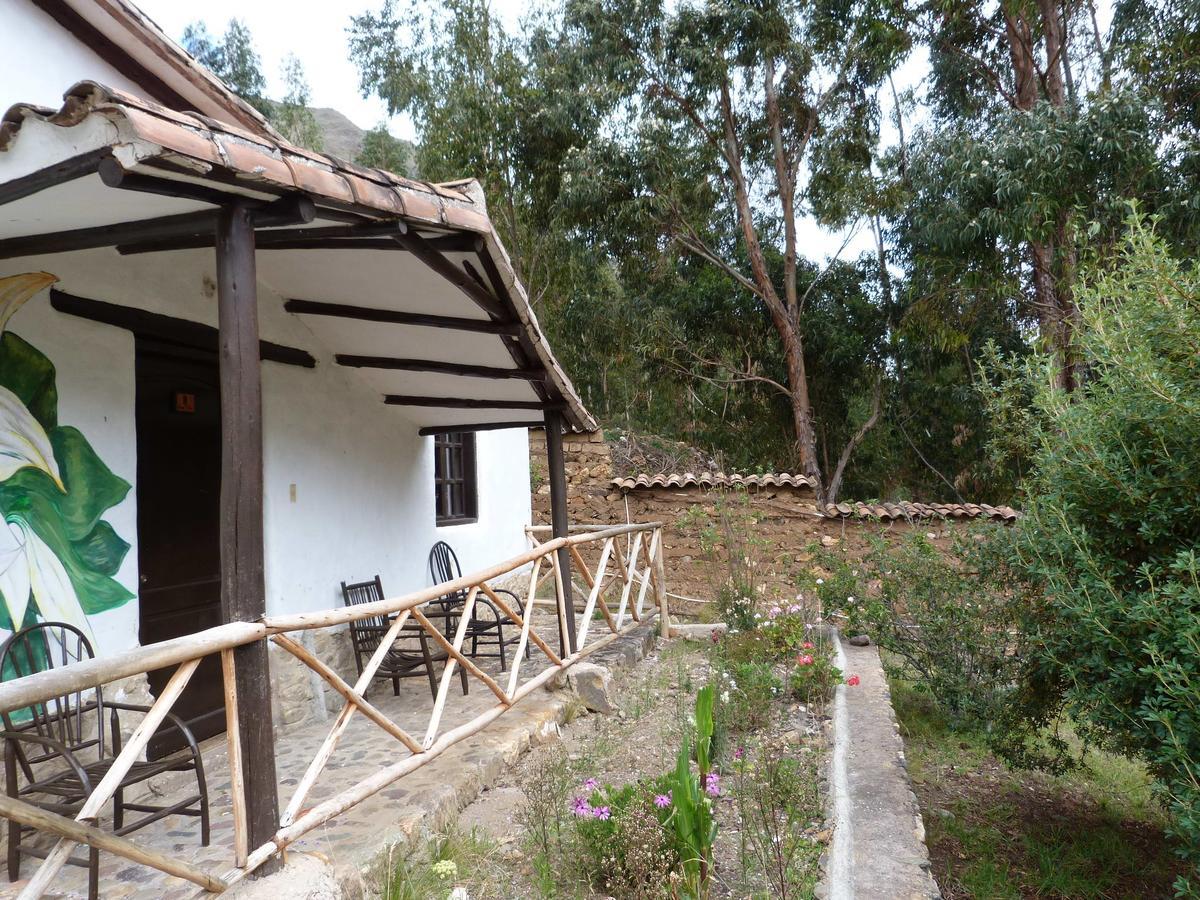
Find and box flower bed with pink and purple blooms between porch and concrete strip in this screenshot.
[380,616,836,900]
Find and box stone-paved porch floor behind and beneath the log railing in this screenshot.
[0,629,590,900]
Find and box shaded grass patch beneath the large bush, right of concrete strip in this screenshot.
[892,679,1182,900]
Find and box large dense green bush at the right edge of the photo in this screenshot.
[984,220,1200,893]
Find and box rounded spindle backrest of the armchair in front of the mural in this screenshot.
[0,622,104,780]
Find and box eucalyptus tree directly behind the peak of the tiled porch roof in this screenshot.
[348,0,609,321]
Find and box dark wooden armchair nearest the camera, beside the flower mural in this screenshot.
[0,622,209,900]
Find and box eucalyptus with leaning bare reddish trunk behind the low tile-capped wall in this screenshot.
[564,0,908,500]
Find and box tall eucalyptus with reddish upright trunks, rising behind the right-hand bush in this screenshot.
[894,0,1194,390]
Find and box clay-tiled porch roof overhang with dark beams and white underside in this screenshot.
[0,82,595,433]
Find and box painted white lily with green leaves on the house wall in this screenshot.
[0,272,133,657]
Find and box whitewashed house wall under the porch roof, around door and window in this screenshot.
[0,250,530,653]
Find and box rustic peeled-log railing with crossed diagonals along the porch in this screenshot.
[0,522,670,900]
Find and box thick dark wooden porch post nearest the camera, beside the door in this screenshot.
[216,203,280,875]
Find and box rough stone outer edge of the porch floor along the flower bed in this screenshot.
[224,622,658,900]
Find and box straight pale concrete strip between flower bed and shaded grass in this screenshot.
[817,640,941,900]
